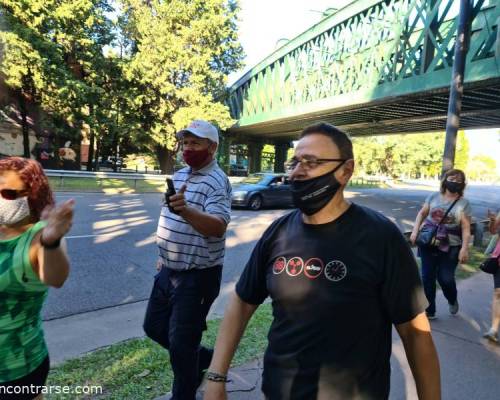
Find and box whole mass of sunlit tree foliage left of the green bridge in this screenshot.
[0,0,243,170]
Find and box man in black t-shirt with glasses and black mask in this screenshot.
[205,123,440,400]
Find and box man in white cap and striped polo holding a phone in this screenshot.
[144,120,231,400]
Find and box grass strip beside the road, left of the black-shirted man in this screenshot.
[46,304,272,400]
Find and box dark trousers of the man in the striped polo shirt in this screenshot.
[144,266,222,400]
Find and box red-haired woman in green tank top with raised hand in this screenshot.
[0,157,74,400]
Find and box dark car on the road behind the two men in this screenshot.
[232,173,293,210]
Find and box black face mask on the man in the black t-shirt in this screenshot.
[292,162,344,215]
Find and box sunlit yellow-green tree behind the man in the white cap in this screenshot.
[120,0,243,172]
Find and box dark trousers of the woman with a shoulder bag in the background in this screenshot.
[418,246,460,314]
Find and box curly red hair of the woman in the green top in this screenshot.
[0,157,54,221]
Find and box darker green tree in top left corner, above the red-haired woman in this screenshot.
[0,0,112,162]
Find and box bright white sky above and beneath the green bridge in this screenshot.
[229,0,500,170]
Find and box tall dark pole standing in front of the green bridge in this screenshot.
[441,0,472,174]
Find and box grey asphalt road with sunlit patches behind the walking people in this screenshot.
[44,187,500,320]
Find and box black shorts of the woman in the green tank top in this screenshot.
[0,356,50,400]
